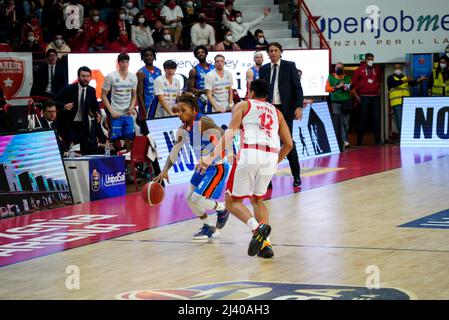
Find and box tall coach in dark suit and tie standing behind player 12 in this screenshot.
[259,42,304,187]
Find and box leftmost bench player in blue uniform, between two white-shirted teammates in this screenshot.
[137,48,162,121]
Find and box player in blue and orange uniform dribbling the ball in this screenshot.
[153,93,229,240]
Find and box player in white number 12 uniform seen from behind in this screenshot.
[201,79,293,258]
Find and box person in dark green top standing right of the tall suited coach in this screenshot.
[326,62,352,147]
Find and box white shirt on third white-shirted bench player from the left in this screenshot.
[204,69,234,111]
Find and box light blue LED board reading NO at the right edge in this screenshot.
[401,97,449,148]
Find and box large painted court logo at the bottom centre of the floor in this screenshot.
[116,281,416,300]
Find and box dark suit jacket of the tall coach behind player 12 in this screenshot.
[259,59,304,121]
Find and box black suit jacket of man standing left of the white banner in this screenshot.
[31,62,67,96]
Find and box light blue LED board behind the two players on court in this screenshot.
[147,102,340,184]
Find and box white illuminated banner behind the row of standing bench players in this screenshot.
[68,50,329,99]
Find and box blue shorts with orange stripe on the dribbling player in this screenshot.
[190,163,229,199]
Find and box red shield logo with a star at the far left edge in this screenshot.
[0,58,25,98]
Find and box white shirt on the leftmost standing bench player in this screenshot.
[103,71,137,114]
